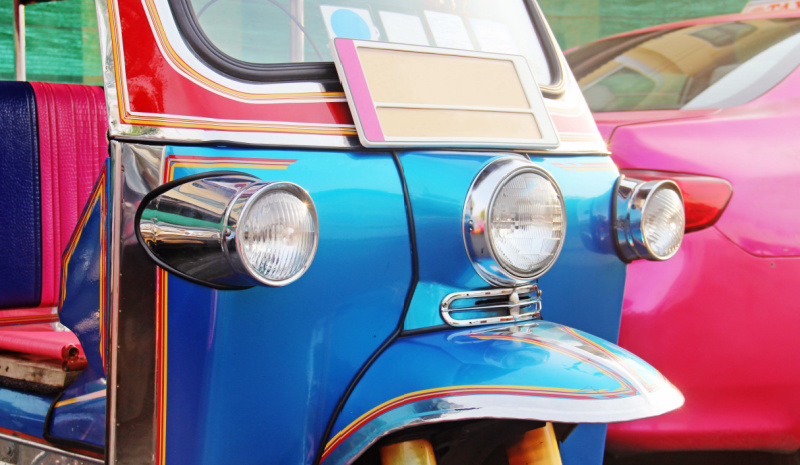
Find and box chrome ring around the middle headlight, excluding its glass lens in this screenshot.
[463,158,567,286]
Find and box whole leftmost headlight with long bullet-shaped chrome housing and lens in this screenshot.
[136,173,318,289]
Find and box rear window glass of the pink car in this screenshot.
[567,18,800,112]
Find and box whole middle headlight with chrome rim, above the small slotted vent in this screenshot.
[464,158,566,286]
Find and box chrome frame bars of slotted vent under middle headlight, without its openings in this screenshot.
[439,284,542,327]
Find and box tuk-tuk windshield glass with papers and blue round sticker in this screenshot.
[189,0,552,84]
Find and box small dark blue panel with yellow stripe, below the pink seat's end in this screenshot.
[50,365,106,448]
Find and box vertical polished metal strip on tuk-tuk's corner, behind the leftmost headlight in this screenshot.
[106,142,163,464]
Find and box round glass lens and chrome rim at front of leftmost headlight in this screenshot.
[226,182,317,286]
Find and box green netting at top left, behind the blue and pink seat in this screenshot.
[0,0,103,84]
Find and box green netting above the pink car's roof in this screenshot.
[539,0,747,50]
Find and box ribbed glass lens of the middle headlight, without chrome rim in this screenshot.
[489,171,564,277]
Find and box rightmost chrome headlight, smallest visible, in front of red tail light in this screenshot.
[614,177,686,262]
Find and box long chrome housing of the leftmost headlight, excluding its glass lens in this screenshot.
[137,174,317,289]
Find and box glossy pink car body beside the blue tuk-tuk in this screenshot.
[568,12,800,452]
